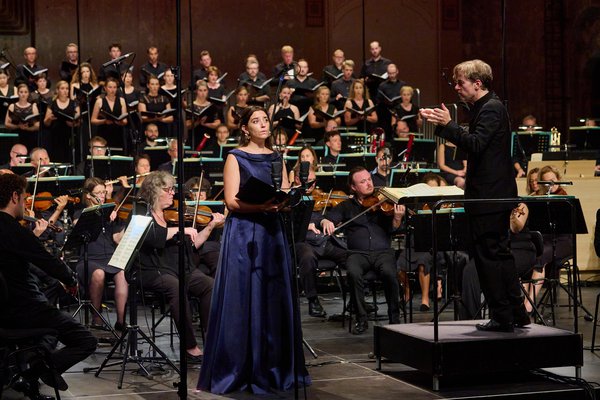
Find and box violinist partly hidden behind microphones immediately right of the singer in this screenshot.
[294,167,347,318]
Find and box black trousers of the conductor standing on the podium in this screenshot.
[468,210,523,324]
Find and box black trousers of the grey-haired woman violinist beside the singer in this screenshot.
[143,269,214,349]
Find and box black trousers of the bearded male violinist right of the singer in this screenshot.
[346,249,400,323]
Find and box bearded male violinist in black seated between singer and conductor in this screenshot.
[320,166,405,335]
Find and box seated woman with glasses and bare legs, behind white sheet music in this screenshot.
[73,178,128,331]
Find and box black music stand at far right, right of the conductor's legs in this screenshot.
[524,196,593,325]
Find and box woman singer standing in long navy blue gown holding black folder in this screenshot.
[198,107,310,394]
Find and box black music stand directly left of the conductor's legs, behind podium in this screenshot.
[414,208,471,321]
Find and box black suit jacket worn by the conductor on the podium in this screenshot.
[435,92,517,213]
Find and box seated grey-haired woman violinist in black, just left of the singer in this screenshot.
[138,171,224,362]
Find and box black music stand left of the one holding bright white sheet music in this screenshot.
[62,203,118,337]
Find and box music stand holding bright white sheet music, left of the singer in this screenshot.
[88,215,179,389]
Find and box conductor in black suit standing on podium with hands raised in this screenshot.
[421,60,531,332]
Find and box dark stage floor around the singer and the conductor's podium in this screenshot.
[3,288,600,400]
